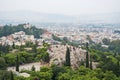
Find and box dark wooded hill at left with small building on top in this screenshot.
[0,24,45,38]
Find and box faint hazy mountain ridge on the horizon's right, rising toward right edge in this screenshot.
[77,12,120,24]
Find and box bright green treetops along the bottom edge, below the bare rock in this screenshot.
[12,65,120,80]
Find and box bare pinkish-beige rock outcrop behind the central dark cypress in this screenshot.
[48,45,86,68]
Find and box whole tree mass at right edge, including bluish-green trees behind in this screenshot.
[90,39,120,76]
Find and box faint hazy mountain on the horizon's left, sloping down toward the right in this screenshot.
[0,11,75,23]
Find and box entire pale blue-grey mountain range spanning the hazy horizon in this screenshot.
[0,11,120,24]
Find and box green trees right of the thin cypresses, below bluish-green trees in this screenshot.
[90,49,120,76]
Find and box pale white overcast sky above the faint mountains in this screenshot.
[0,0,120,15]
